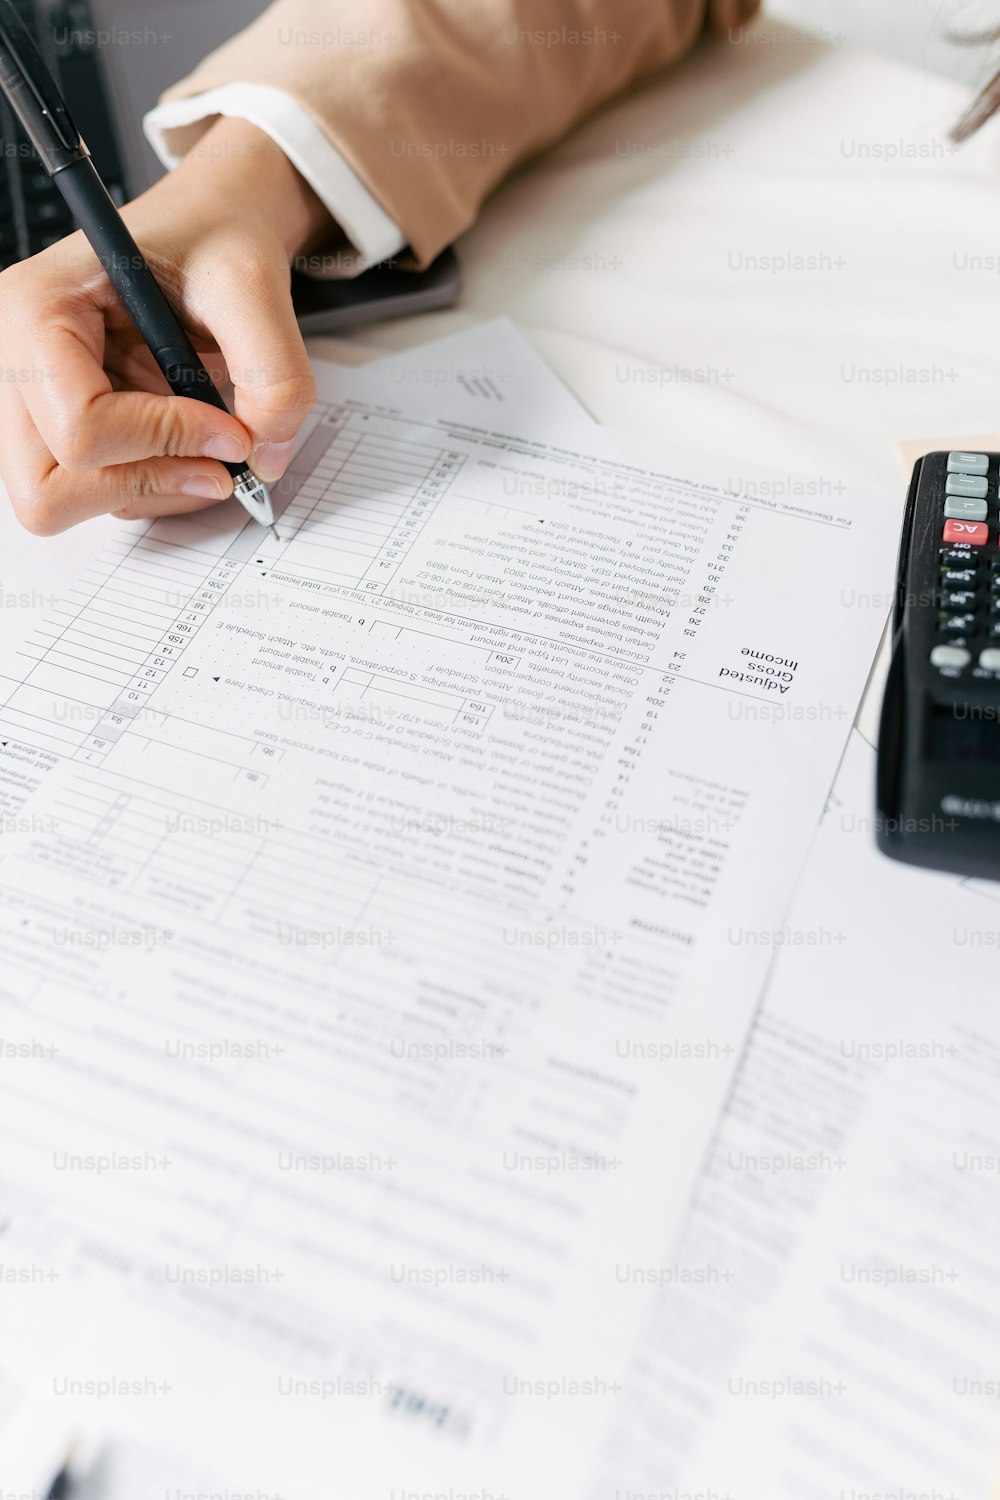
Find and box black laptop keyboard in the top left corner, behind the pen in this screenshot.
[0,0,124,270]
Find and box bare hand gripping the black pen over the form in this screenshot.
[0,119,333,536]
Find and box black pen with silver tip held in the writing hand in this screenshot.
[0,0,277,540]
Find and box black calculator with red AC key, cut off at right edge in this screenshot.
[876,453,1000,879]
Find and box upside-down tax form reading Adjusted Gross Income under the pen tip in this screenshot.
[0,322,897,1500]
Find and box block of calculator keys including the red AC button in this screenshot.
[931,452,1000,677]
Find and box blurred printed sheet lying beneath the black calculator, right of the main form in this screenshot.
[592,734,1000,1500]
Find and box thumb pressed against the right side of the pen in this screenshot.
[211,272,316,483]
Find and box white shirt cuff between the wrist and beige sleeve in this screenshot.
[142,84,406,276]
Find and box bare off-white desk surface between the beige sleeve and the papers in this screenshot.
[332,23,1000,491]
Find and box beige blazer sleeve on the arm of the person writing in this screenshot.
[163,0,760,266]
